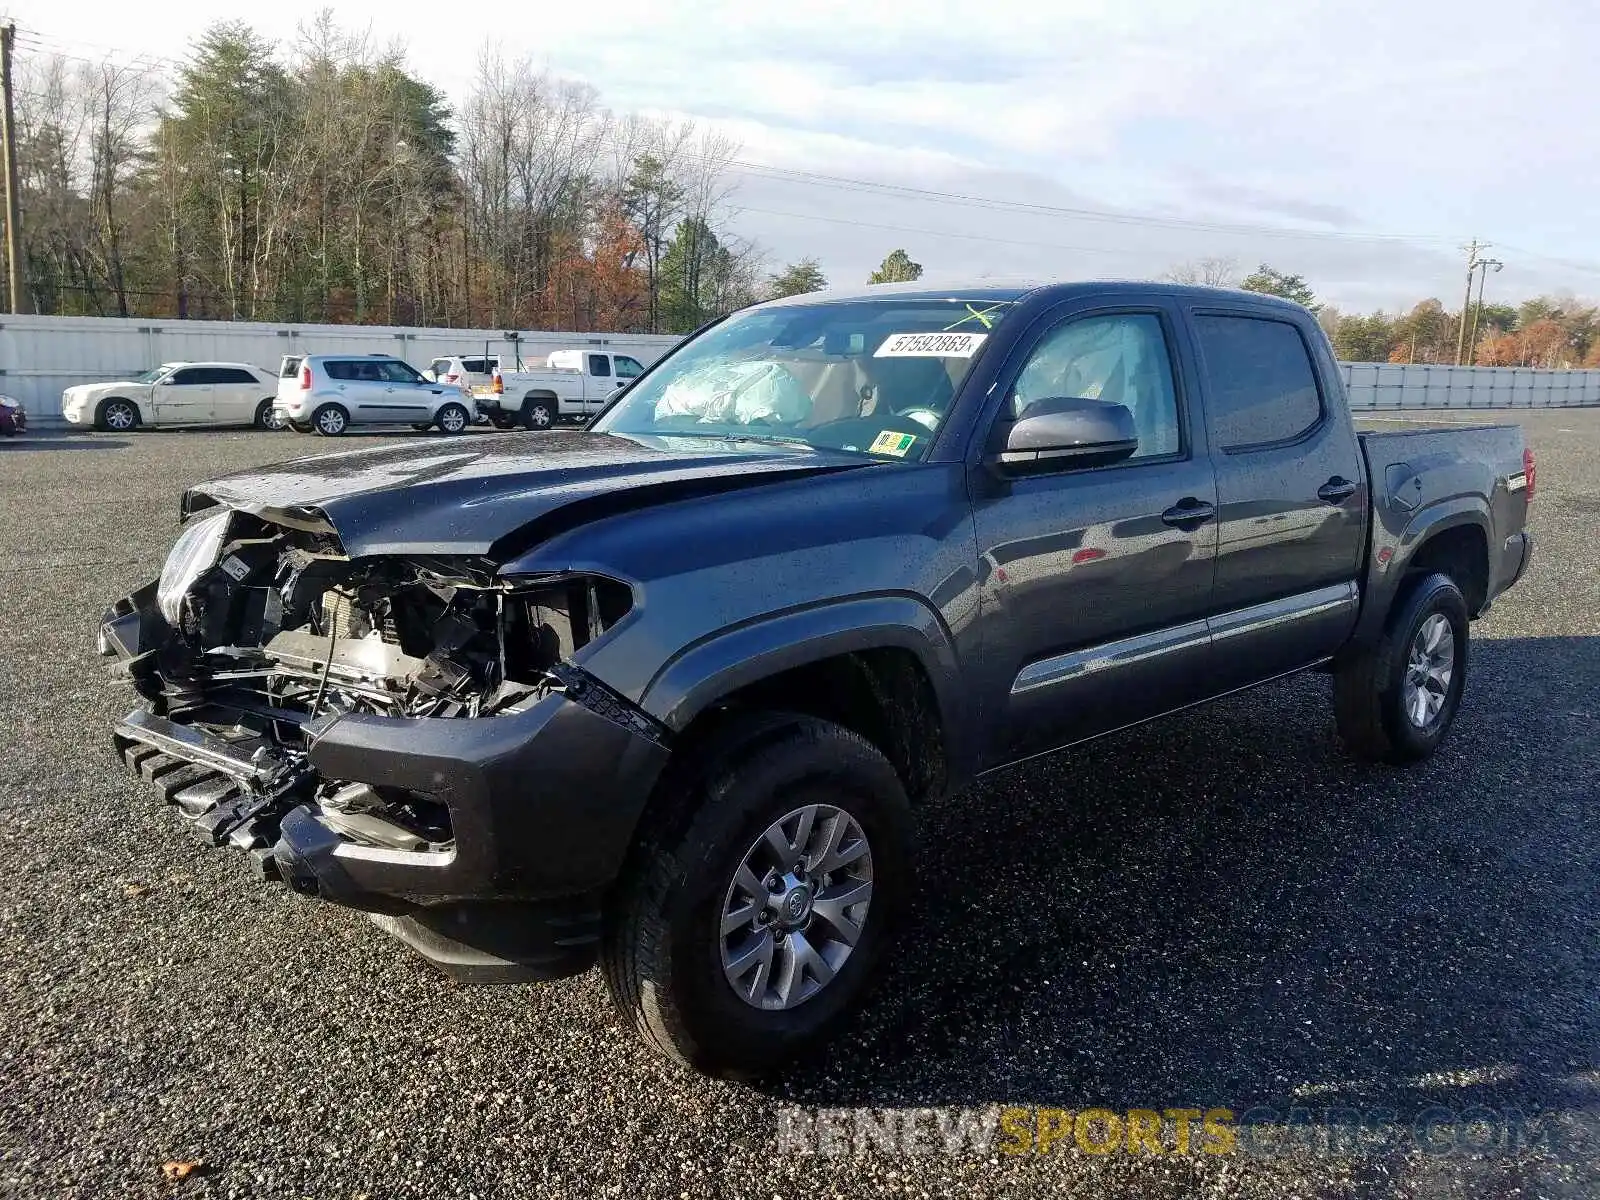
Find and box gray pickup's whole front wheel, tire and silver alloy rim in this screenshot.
[602,715,912,1077]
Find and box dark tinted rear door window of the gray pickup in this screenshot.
[1194,312,1326,453]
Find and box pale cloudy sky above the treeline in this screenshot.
[0,0,1600,310]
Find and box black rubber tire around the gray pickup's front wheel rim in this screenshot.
[602,714,912,1078]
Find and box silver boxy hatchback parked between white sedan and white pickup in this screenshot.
[275,354,477,437]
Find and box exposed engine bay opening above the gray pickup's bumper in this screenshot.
[146,509,632,729]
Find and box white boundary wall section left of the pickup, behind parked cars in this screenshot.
[0,315,680,429]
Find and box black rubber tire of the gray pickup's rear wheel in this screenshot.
[1333,574,1469,763]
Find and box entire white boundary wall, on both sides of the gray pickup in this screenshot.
[0,315,1600,429]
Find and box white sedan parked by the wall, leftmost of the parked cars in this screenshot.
[61,363,278,432]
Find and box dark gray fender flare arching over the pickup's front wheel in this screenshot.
[640,594,971,774]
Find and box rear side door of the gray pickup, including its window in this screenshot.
[1189,306,1366,693]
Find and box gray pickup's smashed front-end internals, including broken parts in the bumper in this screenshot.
[102,507,654,853]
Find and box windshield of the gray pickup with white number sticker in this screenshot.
[595,298,1013,459]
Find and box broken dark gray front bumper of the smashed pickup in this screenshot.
[99,586,667,981]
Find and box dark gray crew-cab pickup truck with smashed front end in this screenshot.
[101,283,1534,1074]
